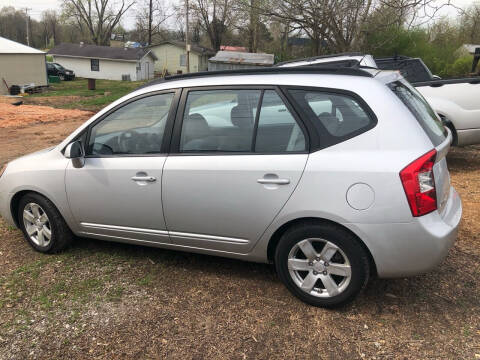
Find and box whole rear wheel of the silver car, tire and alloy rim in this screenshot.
[275,222,370,308]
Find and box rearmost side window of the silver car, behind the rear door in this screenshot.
[289,90,375,139]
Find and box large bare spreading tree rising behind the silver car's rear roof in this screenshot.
[260,0,458,55]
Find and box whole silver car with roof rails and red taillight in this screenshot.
[0,68,462,307]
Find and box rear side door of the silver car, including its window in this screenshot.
[162,87,308,253]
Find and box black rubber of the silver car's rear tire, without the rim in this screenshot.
[275,222,370,308]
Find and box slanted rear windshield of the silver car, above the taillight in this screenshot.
[389,81,447,146]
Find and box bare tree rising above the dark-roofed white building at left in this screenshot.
[63,0,135,45]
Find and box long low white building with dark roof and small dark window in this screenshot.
[48,43,157,81]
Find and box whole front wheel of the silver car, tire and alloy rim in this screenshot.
[17,193,73,254]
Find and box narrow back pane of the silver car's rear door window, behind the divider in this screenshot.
[255,90,305,152]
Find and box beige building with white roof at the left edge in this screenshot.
[0,37,47,95]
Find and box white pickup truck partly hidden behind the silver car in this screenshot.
[277,53,480,146]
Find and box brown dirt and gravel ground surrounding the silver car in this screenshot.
[0,105,480,359]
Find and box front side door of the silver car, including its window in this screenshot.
[65,92,176,242]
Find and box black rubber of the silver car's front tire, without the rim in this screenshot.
[17,193,73,254]
